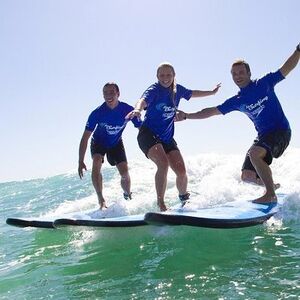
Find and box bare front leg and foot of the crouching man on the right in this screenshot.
[249,146,277,204]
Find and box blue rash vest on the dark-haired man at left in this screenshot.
[85,101,142,148]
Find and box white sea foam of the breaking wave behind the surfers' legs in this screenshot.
[42,148,300,221]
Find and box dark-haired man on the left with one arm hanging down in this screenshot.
[78,82,141,209]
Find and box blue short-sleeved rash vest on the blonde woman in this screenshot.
[141,82,192,144]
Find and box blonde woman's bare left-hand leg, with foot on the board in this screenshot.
[148,144,169,211]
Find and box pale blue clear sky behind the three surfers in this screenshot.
[0,0,300,182]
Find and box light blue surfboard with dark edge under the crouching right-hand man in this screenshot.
[145,195,285,228]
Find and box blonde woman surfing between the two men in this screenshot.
[126,63,220,211]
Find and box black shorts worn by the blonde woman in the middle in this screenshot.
[137,126,179,158]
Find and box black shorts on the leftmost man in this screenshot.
[91,139,127,166]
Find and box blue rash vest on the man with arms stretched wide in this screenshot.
[217,70,290,137]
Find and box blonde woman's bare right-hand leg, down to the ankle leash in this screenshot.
[167,150,188,195]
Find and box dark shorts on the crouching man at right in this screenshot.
[242,129,291,177]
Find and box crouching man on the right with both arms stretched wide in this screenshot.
[176,44,300,204]
